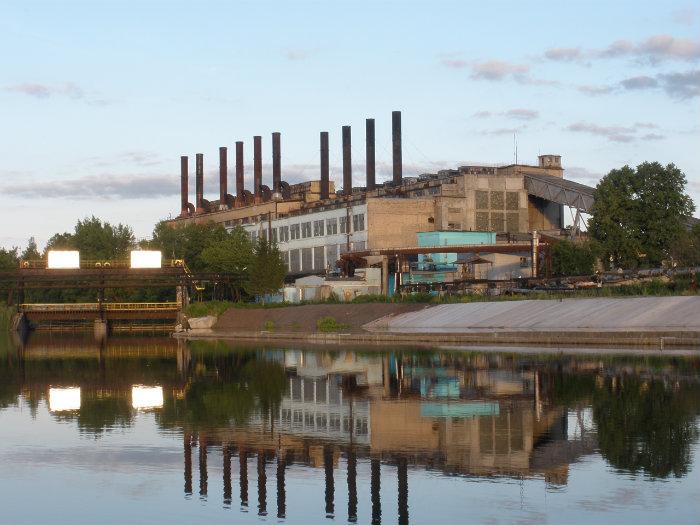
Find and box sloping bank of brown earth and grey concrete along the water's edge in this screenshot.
[181,296,700,349]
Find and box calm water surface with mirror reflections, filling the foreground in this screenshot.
[0,334,700,524]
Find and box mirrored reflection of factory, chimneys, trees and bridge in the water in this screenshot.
[0,334,700,524]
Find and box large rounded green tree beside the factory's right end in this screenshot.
[588,162,695,267]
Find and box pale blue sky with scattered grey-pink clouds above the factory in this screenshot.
[0,0,700,248]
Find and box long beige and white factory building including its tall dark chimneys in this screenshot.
[171,111,593,278]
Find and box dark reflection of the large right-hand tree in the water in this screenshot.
[593,377,700,477]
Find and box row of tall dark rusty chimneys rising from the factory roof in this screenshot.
[180,111,402,217]
